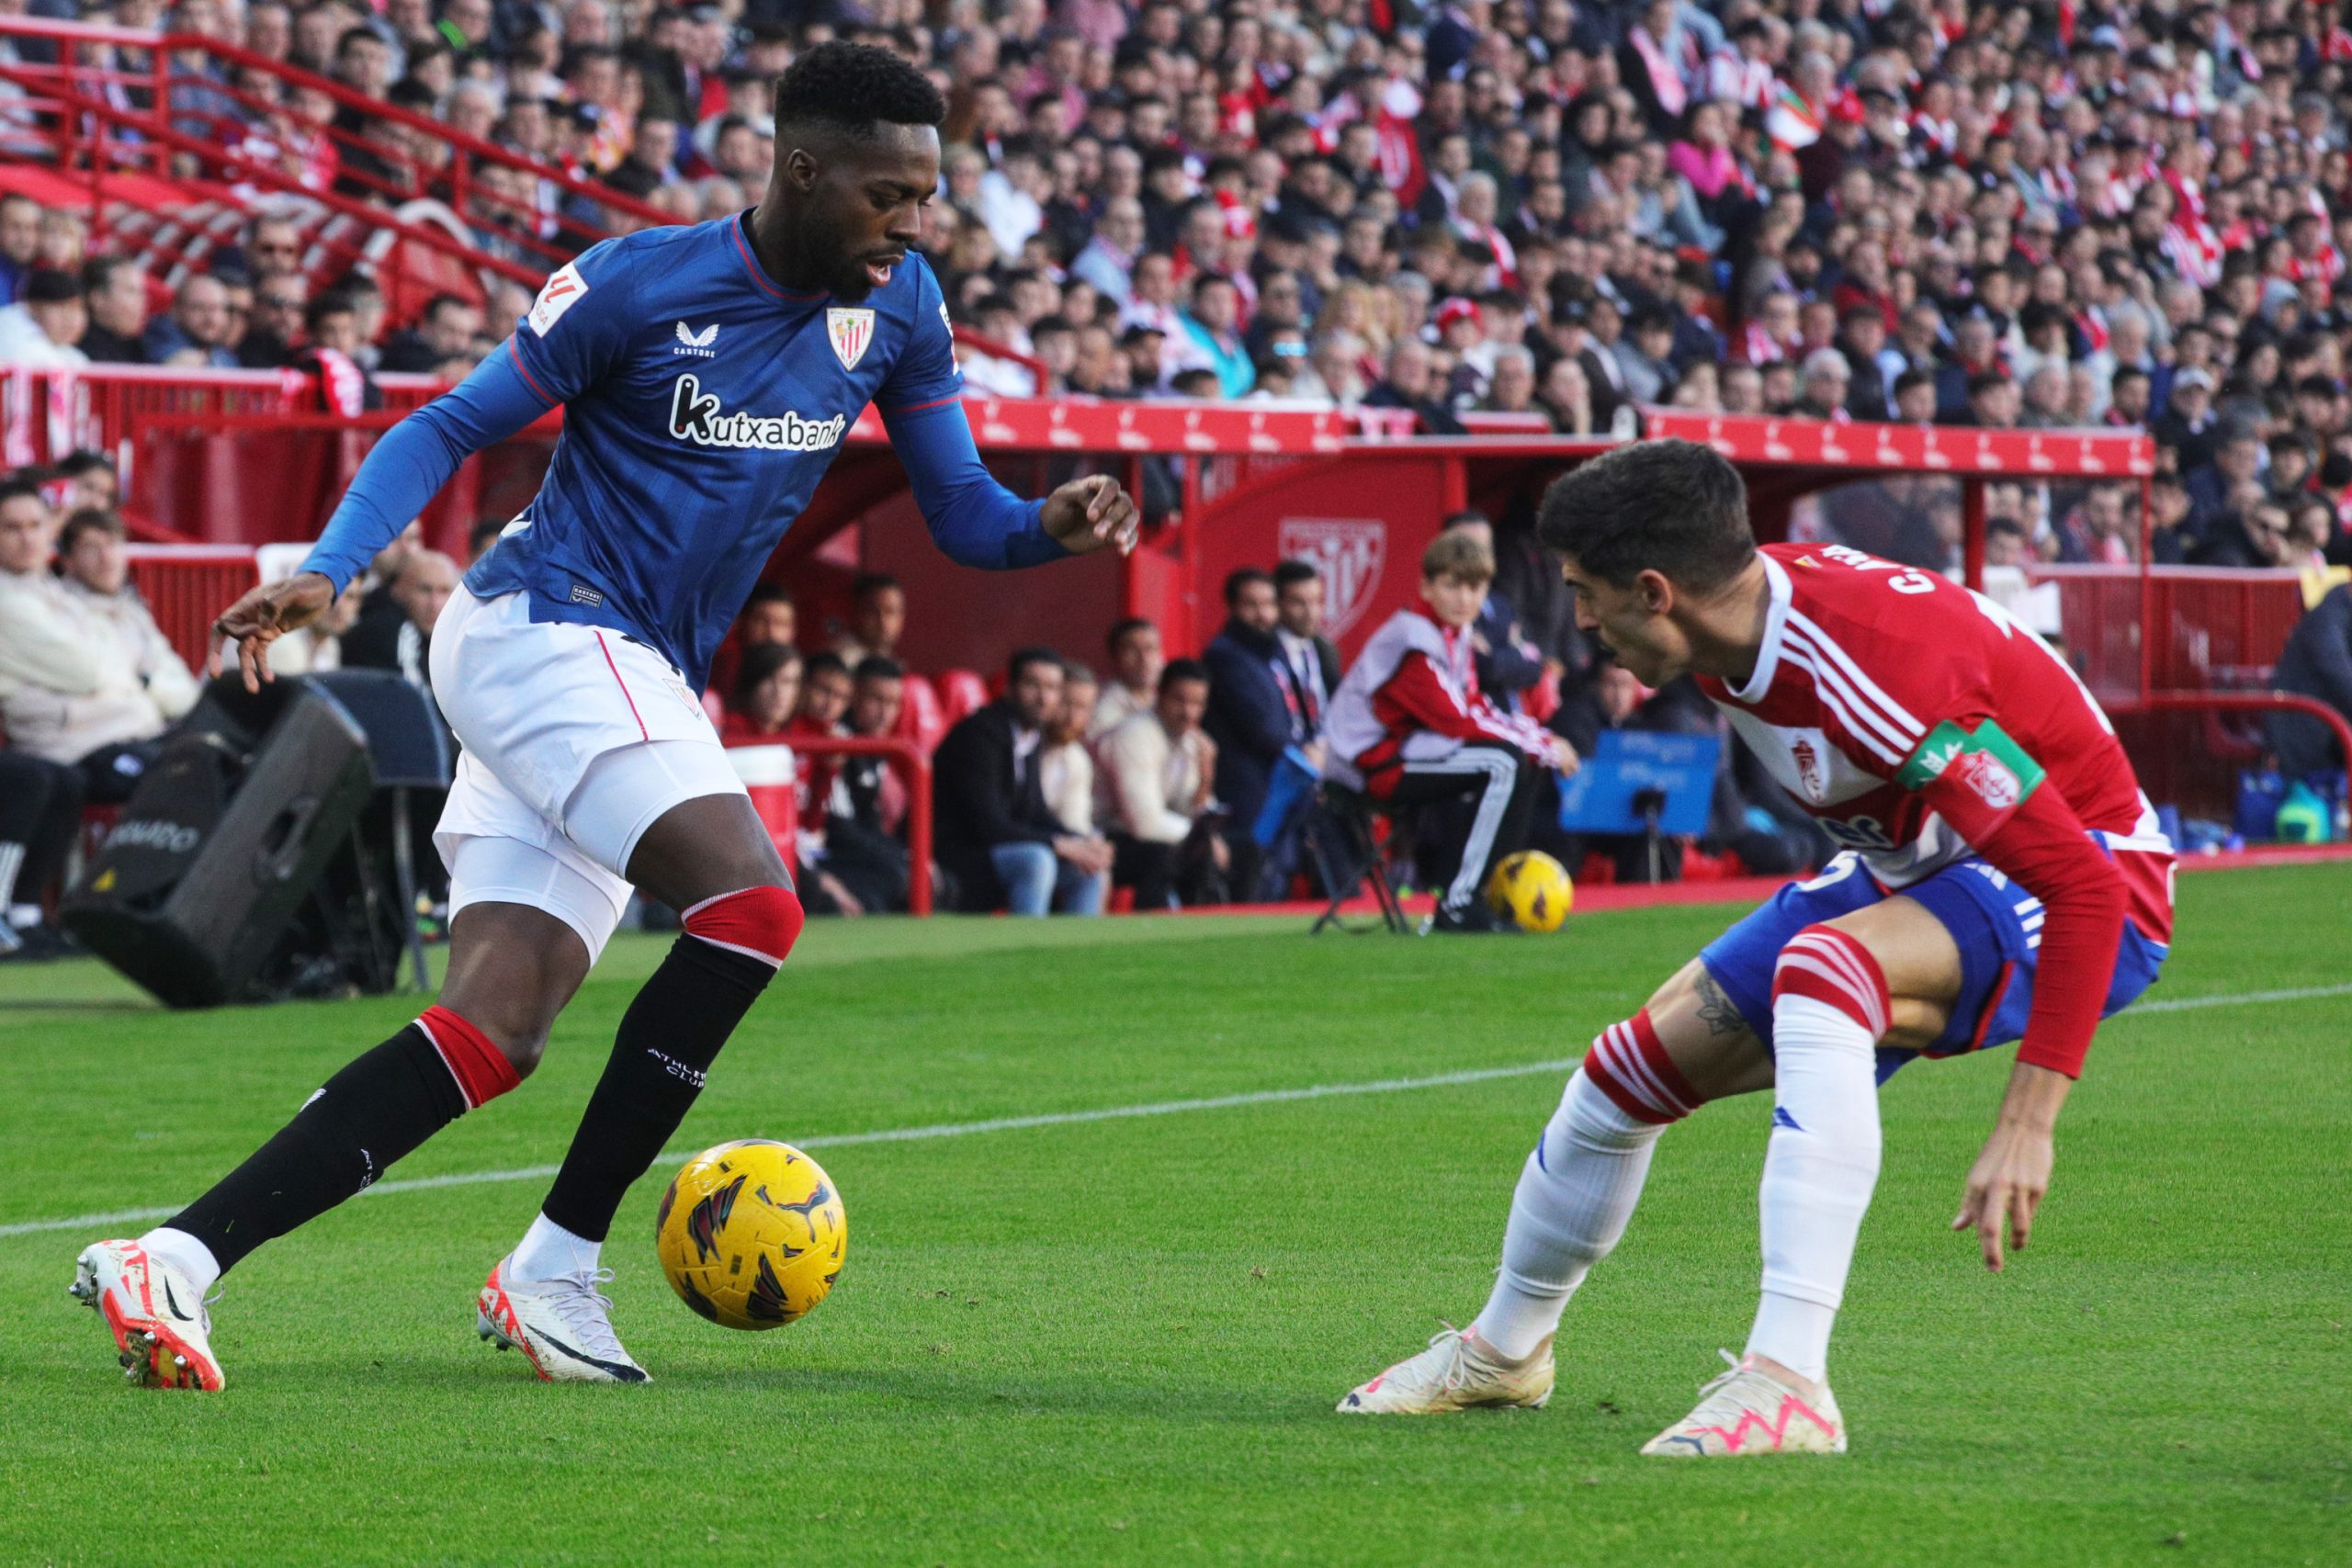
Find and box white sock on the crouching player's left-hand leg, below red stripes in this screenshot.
[1475,1072,1665,1361]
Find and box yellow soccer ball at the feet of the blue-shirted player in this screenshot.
[654,1138,849,1328]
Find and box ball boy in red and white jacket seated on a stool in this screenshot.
[1324,529,1576,931]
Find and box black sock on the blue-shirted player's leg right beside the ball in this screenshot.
[543,936,776,1241]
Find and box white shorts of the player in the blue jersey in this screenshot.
[433,585,743,964]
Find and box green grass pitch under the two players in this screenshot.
[0,865,2352,1568]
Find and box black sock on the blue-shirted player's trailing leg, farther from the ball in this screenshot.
[164,1022,466,1272]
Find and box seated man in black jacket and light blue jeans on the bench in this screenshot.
[932,649,1110,915]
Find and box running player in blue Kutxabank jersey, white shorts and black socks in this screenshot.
[73,42,1136,1389]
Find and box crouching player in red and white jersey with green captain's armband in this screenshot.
[1339,442,2173,1455]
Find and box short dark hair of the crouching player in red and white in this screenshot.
[1536,440,1757,592]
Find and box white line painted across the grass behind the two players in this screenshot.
[0,983,2352,1236]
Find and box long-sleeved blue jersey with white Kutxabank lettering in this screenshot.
[303,214,1063,686]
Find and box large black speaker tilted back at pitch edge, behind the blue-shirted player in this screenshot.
[59,677,398,1006]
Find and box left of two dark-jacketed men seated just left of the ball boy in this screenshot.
[1202,567,1315,898]
